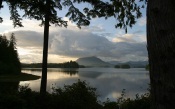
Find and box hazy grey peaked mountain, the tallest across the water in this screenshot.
[76,56,113,67]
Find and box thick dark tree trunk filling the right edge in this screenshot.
[147,0,175,109]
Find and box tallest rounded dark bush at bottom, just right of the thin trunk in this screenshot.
[50,80,101,109]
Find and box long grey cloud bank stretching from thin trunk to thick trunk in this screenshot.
[50,30,147,60]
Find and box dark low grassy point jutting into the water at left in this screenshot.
[0,73,40,81]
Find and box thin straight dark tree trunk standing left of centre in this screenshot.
[40,0,50,94]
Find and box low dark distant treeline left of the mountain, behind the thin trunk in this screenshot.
[21,61,84,68]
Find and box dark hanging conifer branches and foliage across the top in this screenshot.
[0,0,146,32]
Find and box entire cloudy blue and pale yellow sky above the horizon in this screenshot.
[0,1,148,63]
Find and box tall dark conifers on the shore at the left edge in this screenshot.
[0,33,21,74]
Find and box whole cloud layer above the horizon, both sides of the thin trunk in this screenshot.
[3,26,147,62]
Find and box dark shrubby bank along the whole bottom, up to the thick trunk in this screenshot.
[0,80,150,109]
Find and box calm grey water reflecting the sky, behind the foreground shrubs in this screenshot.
[20,68,149,101]
